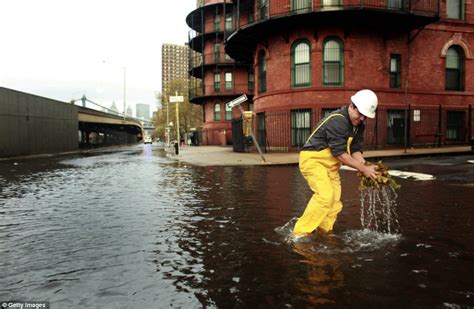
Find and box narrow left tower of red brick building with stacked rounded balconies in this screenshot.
[186,1,254,145]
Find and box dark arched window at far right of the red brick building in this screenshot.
[445,45,464,91]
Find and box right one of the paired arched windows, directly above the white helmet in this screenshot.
[323,38,344,86]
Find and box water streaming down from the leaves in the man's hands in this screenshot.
[360,186,400,234]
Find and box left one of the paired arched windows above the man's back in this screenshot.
[291,41,311,87]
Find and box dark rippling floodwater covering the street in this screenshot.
[0,145,474,308]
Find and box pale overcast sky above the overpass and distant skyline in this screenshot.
[0,0,196,111]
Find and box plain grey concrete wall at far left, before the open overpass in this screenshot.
[0,87,78,157]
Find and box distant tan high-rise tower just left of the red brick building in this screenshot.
[161,44,190,93]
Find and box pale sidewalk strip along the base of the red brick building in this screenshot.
[169,146,474,166]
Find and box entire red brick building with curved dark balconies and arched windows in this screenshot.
[187,0,474,151]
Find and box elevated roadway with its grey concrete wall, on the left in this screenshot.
[0,87,150,158]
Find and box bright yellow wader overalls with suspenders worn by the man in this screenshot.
[293,113,353,236]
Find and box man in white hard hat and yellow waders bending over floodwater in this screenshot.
[293,89,378,238]
